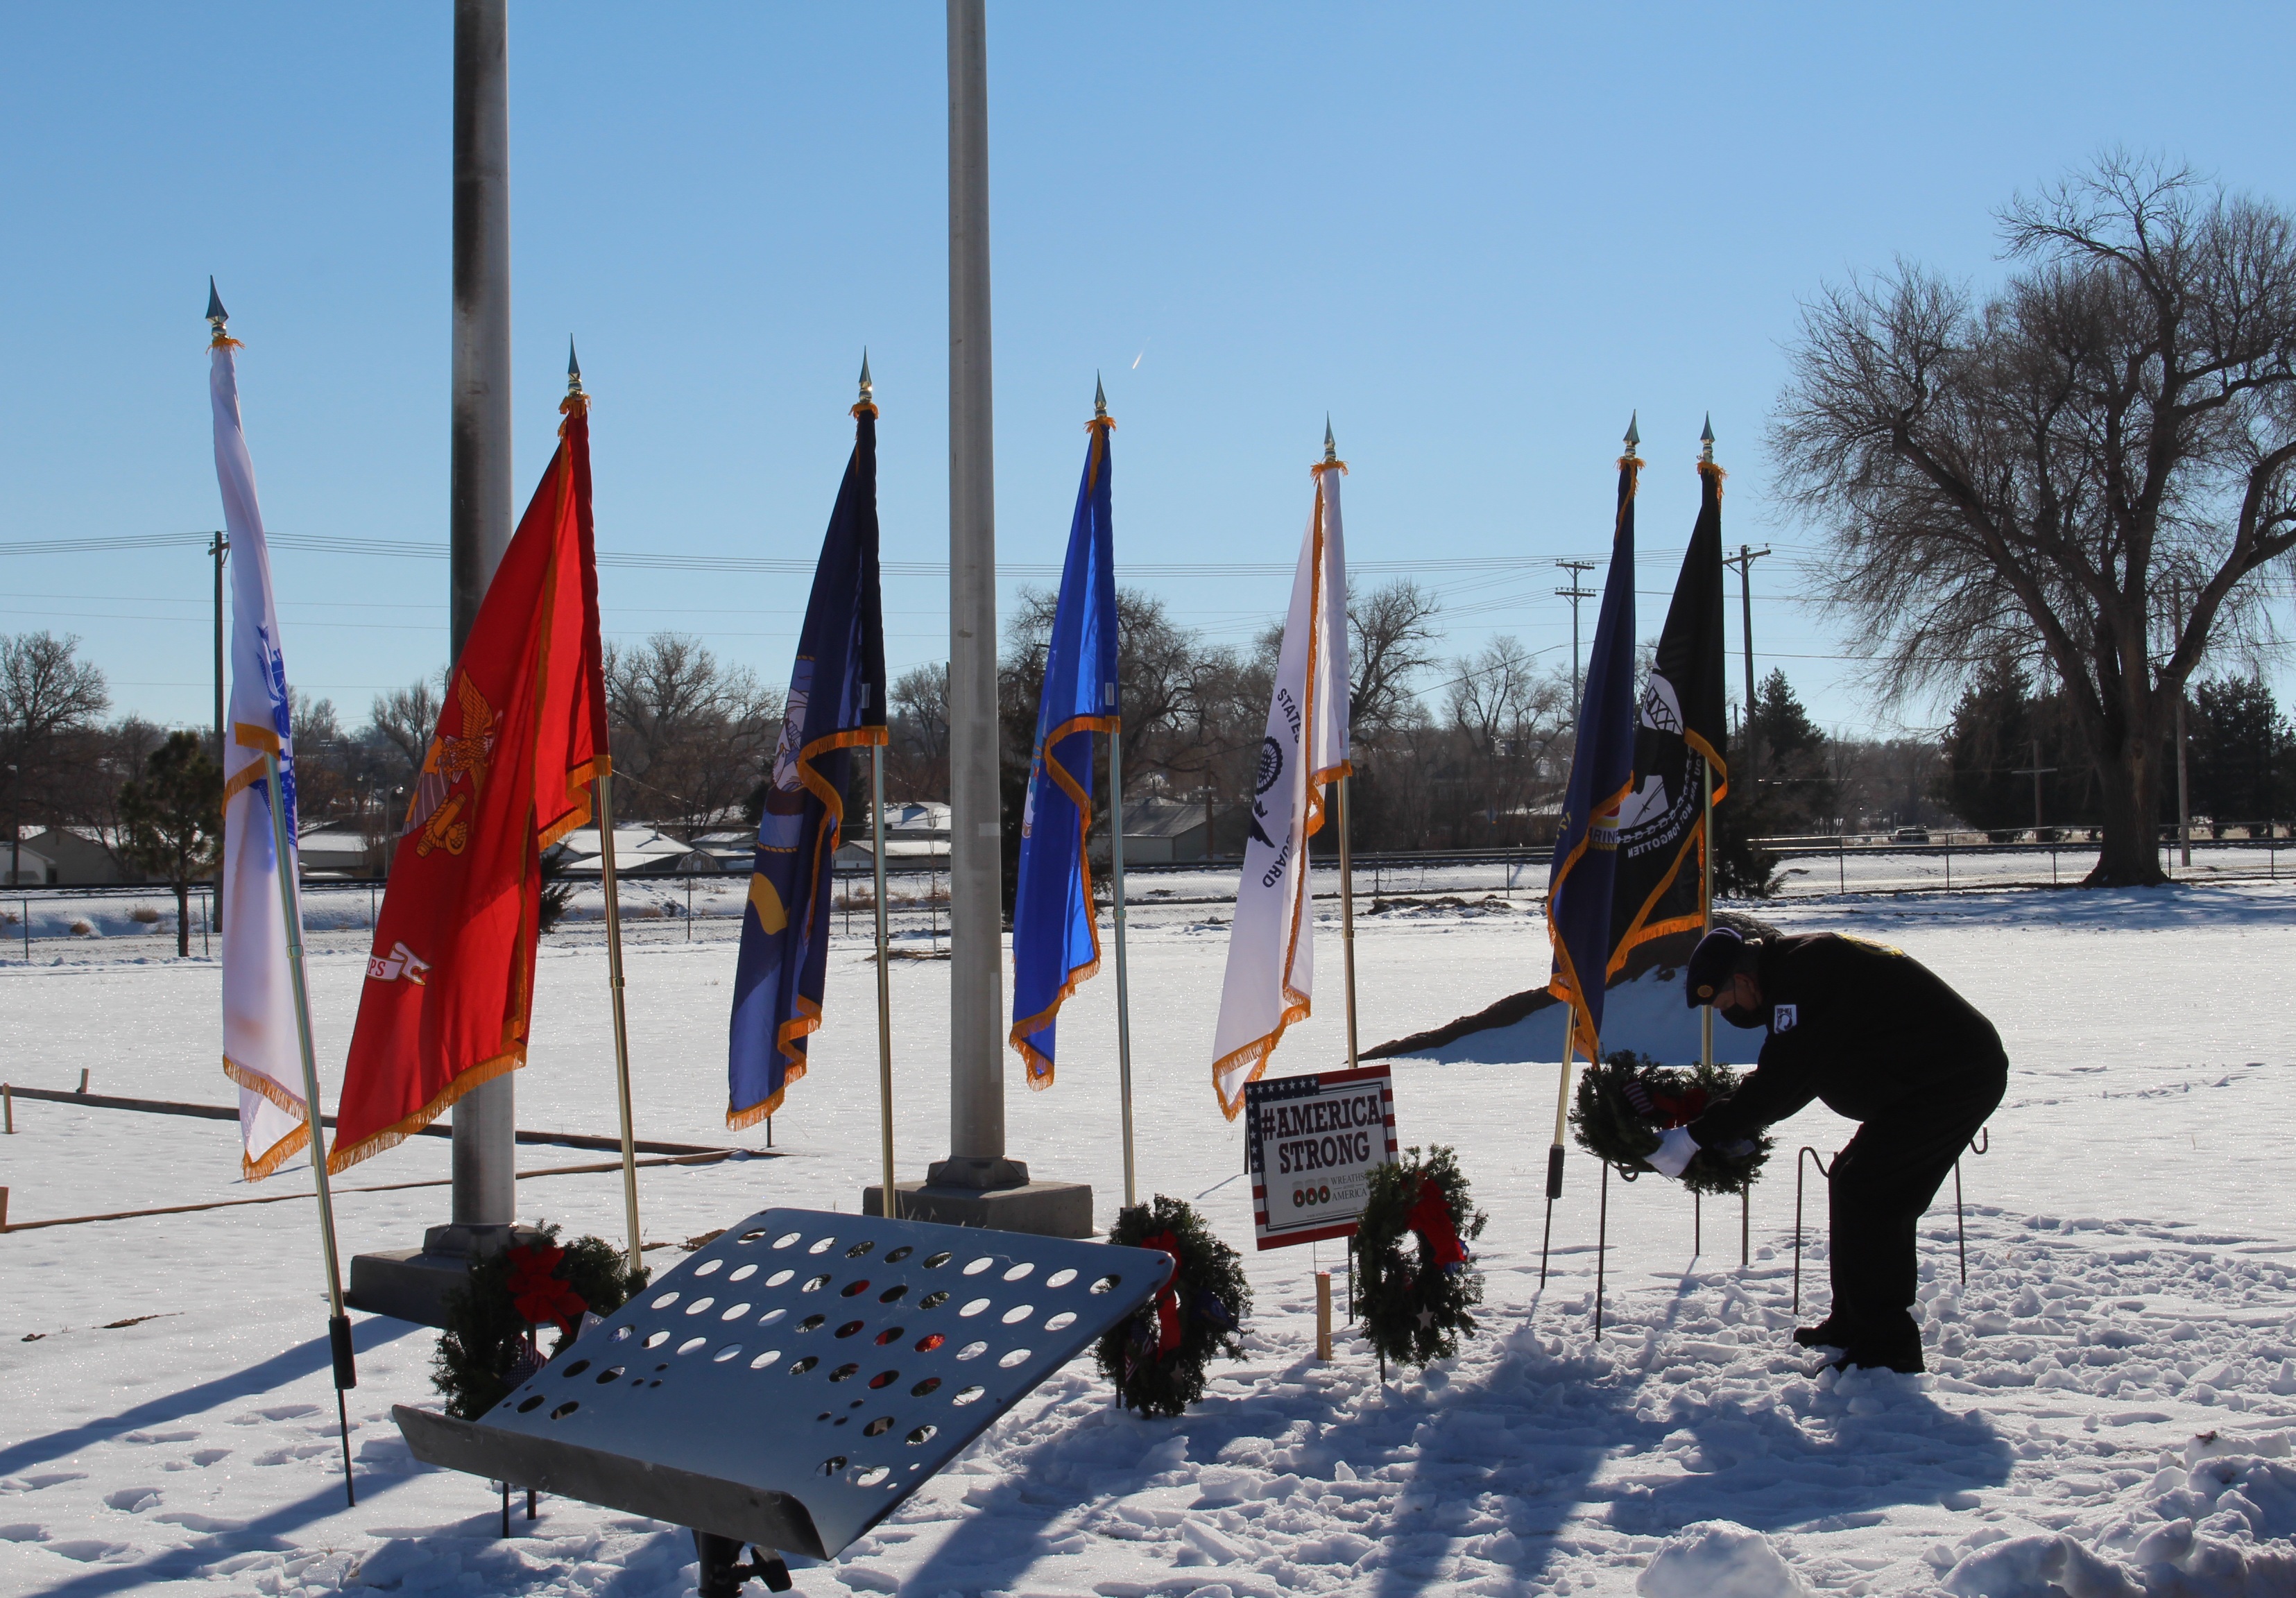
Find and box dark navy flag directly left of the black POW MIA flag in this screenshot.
[1548,438,1642,1060]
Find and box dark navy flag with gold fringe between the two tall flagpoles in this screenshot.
[726,400,886,1127]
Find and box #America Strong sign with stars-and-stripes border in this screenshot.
[1244,1065,1396,1249]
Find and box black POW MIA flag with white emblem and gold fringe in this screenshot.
[1605,461,1729,981]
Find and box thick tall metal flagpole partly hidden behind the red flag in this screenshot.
[447,0,517,1253]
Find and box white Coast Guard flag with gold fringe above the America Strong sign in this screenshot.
[1213,461,1348,1120]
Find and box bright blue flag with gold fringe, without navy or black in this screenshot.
[1013,415,1123,1088]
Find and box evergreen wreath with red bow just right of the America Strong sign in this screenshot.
[1355,1144,1490,1366]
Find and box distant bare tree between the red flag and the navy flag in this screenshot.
[604,631,780,827]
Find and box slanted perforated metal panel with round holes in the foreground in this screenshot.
[477,1210,1171,1554]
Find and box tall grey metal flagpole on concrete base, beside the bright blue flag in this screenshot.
[923,0,1093,1237]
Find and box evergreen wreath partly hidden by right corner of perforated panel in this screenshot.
[1093,1194,1251,1416]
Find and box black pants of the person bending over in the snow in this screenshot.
[1828,1063,2009,1341]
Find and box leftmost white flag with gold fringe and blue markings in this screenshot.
[207,333,310,1183]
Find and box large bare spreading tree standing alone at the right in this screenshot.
[1770,154,2296,884]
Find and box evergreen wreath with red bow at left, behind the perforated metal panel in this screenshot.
[431,1221,650,1421]
